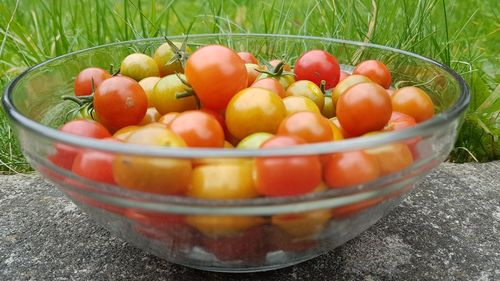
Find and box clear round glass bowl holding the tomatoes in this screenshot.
[2,34,469,272]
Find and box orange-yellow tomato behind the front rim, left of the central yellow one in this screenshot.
[113,126,191,194]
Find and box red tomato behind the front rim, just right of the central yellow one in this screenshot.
[255,136,321,196]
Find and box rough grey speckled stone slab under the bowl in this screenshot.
[0,162,500,281]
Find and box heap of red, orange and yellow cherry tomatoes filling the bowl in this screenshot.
[49,41,434,199]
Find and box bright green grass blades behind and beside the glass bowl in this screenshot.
[0,0,500,172]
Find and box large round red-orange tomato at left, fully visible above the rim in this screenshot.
[94,77,148,131]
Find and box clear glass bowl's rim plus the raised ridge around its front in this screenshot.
[2,33,470,215]
